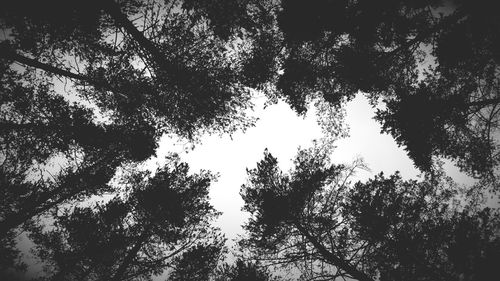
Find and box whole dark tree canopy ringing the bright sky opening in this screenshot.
[0,0,500,281]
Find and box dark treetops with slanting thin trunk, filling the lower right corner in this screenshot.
[241,148,500,281]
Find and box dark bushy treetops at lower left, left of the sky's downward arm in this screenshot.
[31,155,225,280]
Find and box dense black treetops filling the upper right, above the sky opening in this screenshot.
[188,0,500,179]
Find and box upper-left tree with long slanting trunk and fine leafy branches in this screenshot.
[2,0,258,136]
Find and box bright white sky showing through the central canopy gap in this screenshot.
[151,95,472,244]
